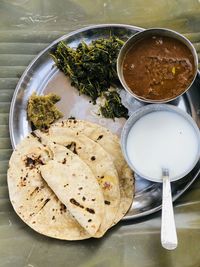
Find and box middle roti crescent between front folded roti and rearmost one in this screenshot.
[35,127,120,237]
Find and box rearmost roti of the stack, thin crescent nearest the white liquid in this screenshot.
[51,119,134,224]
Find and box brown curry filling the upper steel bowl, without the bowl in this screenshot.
[123,36,195,101]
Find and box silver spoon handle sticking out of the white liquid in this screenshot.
[161,169,178,250]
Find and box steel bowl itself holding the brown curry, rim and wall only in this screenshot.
[117,28,198,103]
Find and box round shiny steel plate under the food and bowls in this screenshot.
[9,24,200,220]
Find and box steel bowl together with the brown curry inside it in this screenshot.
[118,29,198,103]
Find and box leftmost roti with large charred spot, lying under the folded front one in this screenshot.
[7,134,91,240]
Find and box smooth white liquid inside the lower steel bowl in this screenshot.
[127,111,198,182]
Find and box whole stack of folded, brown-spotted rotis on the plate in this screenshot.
[8,120,134,240]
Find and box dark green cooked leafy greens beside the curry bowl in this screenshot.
[51,36,127,118]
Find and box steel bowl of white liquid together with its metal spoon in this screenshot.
[121,104,200,250]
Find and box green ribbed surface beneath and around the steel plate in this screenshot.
[0,0,200,267]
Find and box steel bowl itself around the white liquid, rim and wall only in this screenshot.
[121,104,200,182]
